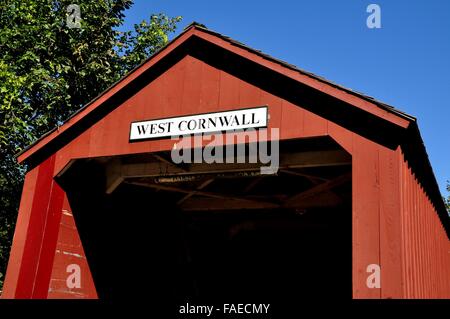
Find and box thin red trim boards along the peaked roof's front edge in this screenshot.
[17,22,415,163]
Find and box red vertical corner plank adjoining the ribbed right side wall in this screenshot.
[379,147,402,299]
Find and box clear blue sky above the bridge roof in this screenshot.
[121,0,450,194]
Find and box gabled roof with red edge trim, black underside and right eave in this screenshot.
[17,22,450,234]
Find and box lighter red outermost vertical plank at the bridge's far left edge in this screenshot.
[2,166,39,299]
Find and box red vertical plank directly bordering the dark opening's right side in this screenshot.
[352,136,383,299]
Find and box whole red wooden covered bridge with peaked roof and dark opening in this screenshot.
[2,24,450,298]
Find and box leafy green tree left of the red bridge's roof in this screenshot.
[0,0,181,289]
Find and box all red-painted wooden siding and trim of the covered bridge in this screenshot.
[2,24,450,298]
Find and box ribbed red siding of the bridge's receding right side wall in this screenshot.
[399,155,450,298]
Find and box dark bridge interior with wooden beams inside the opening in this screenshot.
[58,138,352,303]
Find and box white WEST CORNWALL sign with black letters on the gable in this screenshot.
[130,106,267,142]
